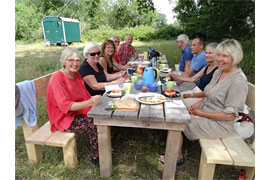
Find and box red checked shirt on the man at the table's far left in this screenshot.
[117,42,136,65]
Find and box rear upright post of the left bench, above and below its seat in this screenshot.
[21,118,42,164]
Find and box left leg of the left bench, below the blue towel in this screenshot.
[25,143,42,164]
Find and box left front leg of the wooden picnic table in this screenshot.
[97,125,112,178]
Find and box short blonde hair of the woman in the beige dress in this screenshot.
[215,39,243,65]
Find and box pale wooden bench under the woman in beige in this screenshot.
[198,83,255,180]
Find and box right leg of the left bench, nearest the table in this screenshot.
[63,137,78,169]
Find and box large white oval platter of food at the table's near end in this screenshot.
[135,93,166,104]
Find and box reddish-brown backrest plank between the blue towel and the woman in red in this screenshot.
[33,72,54,99]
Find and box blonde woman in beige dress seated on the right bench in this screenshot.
[160,39,248,165]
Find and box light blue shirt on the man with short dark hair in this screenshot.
[189,51,208,85]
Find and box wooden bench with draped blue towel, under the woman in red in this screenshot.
[18,73,78,168]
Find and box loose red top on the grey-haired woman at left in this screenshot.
[46,71,92,132]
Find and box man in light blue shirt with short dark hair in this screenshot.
[169,37,208,92]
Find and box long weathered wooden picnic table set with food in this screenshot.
[88,73,190,179]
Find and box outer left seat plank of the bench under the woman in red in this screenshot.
[25,121,55,145]
